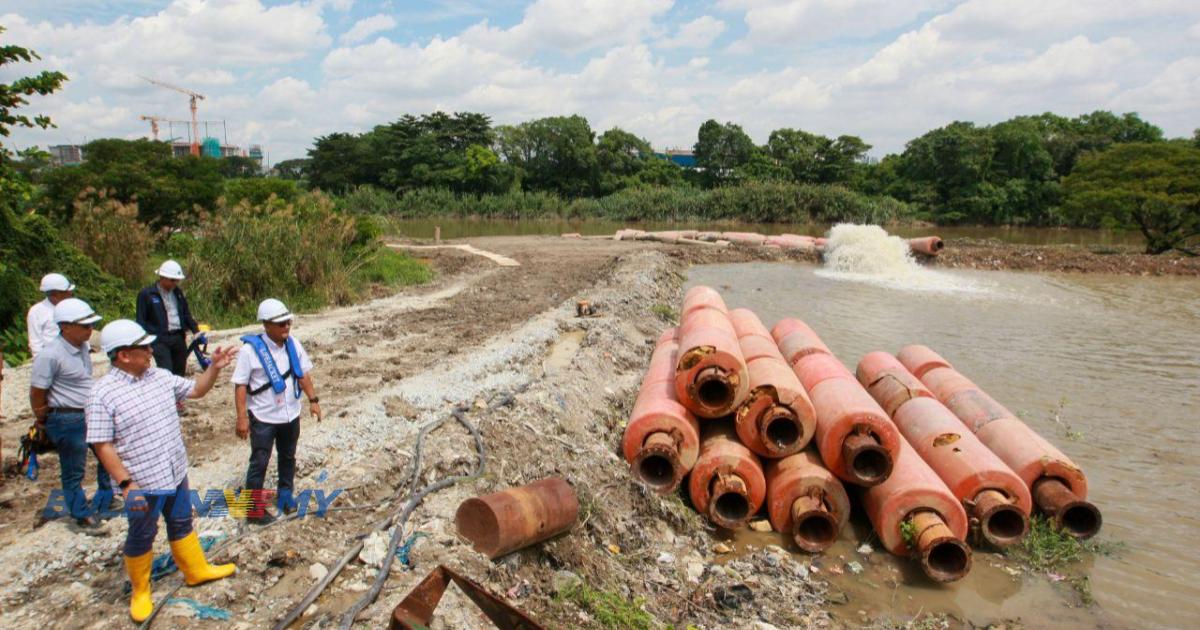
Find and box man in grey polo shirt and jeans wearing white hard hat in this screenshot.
[29,298,113,533]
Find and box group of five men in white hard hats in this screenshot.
[28,260,322,622]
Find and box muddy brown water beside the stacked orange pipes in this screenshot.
[688,249,1200,628]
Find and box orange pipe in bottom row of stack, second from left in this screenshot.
[688,421,767,529]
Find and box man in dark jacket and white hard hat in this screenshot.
[137,260,200,377]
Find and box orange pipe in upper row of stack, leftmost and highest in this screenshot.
[676,287,750,418]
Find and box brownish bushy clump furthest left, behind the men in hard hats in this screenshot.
[66,188,154,288]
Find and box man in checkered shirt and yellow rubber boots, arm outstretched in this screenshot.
[86,319,236,622]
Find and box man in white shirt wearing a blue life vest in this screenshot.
[233,298,320,524]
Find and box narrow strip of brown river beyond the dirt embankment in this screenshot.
[394,218,1142,247]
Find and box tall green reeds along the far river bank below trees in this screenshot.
[340,181,912,223]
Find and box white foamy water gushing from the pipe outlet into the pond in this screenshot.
[816,223,988,293]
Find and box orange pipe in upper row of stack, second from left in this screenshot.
[730,308,817,457]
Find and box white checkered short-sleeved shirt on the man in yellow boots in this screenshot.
[85,367,196,492]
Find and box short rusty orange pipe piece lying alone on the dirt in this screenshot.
[454,476,580,559]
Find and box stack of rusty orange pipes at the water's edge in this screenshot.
[622,286,1100,582]
